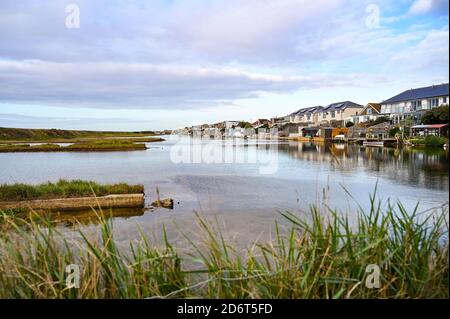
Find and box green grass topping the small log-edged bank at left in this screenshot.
[0,179,144,202]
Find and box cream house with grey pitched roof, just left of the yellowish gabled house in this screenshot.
[318,101,364,126]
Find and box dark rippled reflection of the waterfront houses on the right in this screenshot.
[279,143,449,190]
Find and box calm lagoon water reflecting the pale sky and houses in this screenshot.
[0,136,449,244]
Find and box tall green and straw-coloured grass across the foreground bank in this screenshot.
[0,198,449,298]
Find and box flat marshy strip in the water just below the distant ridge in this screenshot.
[0,137,163,153]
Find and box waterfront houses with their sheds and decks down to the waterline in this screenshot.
[174,84,448,148]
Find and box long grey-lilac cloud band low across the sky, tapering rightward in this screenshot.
[0,60,363,109]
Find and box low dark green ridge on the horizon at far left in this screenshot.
[0,127,153,140]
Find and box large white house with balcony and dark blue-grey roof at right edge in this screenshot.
[380,83,449,124]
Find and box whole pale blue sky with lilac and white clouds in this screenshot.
[0,0,449,131]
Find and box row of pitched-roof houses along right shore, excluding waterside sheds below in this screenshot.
[177,83,449,137]
